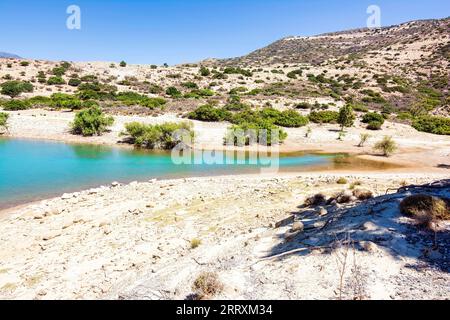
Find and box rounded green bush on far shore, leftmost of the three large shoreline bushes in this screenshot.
[71,107,114,137]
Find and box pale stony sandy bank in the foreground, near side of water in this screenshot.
[0,173,450,299]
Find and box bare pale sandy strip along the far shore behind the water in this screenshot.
[5,109,450,172]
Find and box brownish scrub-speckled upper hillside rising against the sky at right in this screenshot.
[221,18,450,69]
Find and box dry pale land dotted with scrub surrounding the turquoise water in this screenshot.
[0,18,450,299]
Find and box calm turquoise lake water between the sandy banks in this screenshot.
[0,139,334,208]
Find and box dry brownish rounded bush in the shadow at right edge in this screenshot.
[400,194,450,225]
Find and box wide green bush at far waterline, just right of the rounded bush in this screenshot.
[121,122,194,150]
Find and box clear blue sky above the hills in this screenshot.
[0,0,450,64]
